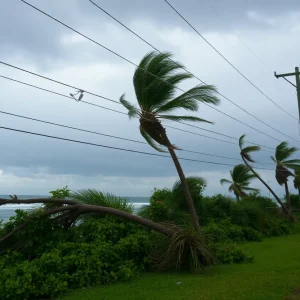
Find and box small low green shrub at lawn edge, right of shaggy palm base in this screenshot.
[215,244,254,264]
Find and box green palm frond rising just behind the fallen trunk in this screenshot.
[70,189,133,213]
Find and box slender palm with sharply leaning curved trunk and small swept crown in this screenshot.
[239,134,295,220]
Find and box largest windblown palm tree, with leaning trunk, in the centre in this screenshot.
[120,52,219,231]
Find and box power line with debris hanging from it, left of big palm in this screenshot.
[0,74,274,152]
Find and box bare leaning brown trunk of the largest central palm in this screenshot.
[162,129,200,232]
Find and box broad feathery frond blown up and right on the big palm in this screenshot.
[155,85,220,113]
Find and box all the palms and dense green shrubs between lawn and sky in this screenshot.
[0,52,300,300]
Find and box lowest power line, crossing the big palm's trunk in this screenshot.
[0,126,273,171]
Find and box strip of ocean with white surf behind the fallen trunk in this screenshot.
[0,195,149,222]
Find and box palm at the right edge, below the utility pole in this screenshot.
[271,142,300,210]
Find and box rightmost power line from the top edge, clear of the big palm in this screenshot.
[164,0,298,121]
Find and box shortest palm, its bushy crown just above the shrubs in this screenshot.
[220,164,259,201]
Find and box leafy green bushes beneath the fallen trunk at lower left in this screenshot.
[0,217,150,300]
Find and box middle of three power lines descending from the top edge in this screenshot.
[89,0,298,141]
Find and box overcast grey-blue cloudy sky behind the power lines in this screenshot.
[0,0,300,196]
